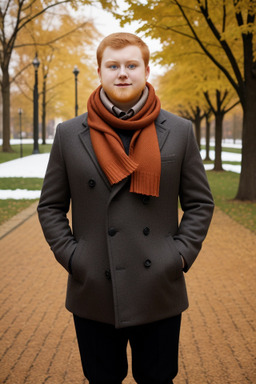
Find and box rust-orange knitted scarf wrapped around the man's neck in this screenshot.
[87,83,161,196]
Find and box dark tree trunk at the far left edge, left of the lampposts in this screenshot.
[1,64,12,152]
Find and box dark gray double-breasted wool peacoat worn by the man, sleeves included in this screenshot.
[38,110,214,328]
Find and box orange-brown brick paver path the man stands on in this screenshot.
[0,209,256,384]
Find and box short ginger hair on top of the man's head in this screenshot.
[96,32,150,68]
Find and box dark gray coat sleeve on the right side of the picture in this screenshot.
[174,122,214,272]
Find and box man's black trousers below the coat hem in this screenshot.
[74,315,181,384]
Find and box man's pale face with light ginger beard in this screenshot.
[98,45,149,111]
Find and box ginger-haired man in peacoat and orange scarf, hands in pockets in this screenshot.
[38,33,213,384]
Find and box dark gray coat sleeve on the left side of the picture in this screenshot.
[37,126,77,271]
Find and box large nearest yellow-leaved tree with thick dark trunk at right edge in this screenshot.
[120,0,256,201]
